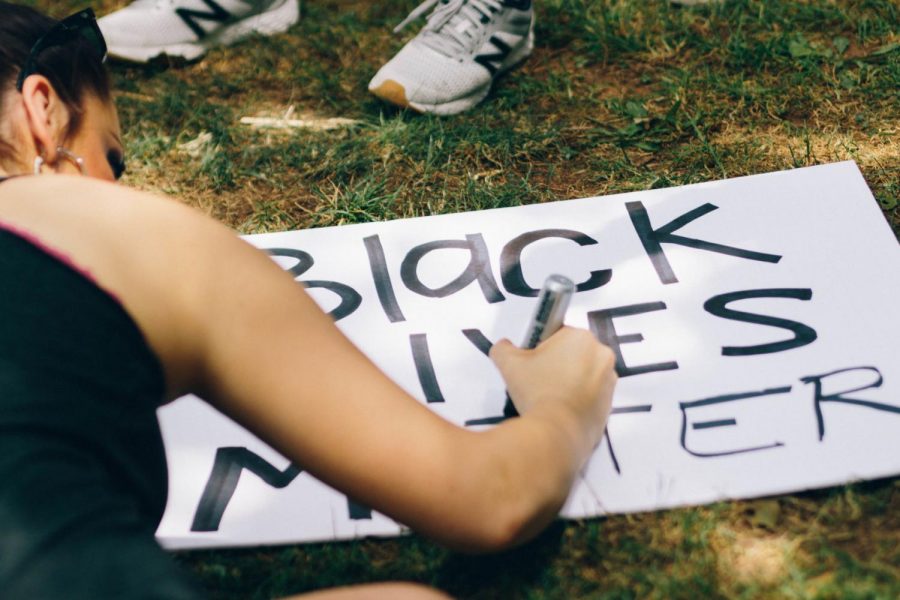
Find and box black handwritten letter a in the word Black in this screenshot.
[400,234,506,304]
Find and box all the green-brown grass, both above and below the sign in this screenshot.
[24,0,900,599]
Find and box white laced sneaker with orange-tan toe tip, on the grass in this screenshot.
[369,0,534,115]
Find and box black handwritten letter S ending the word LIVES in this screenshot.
[703,288,818,356]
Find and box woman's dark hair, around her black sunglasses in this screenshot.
[0,1,110,160]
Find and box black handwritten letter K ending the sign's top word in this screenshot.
[625,201,781,284]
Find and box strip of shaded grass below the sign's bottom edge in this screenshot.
[181,480,900,599]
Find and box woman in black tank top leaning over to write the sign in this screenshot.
[0,2,615,599]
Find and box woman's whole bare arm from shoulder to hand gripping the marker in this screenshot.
[0,177,615,551]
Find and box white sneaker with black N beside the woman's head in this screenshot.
[97,0,300,63]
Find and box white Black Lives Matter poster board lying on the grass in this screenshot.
[157,162,900,548]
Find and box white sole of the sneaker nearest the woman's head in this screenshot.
[108,0,300,64]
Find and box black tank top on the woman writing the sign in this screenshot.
[0,176,203,600]
